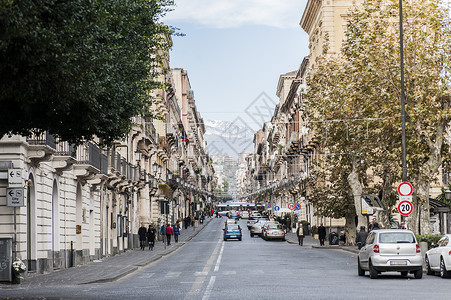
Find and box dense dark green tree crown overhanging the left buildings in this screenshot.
[0,0,172,143]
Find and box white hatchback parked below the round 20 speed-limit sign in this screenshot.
[357,229,423,279]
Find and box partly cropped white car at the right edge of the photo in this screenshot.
[425,234,451,278]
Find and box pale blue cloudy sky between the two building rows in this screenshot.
[163,0,308,129]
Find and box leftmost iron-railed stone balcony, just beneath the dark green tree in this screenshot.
[27,131,56,163]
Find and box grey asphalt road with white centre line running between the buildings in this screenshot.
[0,218,451,299]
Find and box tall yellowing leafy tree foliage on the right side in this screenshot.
[307,0,451,233]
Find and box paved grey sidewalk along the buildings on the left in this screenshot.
[0,218,213,289]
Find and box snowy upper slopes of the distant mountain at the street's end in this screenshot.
[204,118,254,158]
